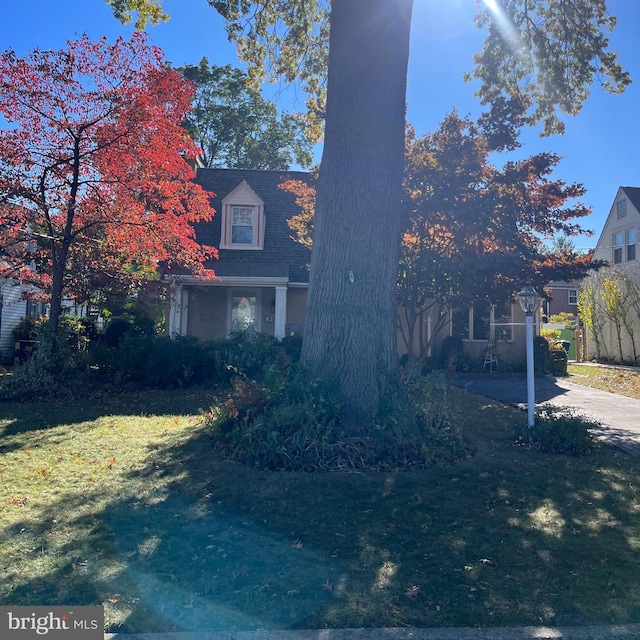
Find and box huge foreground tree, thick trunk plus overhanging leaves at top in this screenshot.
[107,0,624,416]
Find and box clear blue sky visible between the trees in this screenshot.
[0,0,640,249]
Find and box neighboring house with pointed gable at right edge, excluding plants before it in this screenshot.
[589,187,640,363]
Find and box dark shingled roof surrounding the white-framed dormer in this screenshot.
[195,169,312,283]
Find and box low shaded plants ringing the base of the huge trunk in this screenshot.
[207,364,464,471]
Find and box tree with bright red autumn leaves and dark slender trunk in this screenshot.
[0,33,215,328]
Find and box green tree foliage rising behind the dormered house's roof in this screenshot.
[178,58,312,170]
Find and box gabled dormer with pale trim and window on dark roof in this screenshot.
[220,180,265,250]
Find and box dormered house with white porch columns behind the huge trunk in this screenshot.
[165,168,536,370]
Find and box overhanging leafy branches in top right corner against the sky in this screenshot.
[467,0,631,135]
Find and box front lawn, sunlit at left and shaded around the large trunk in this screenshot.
[0,382,640,632]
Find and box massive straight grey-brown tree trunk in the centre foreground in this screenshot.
[302,0,413,417]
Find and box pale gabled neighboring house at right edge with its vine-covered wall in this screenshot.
[587,187,640,364]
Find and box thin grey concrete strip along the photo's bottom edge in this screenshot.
[105,624,640,640]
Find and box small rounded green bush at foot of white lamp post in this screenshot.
[531,404,600,456]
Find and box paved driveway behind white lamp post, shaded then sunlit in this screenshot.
[450,376,640,456]
